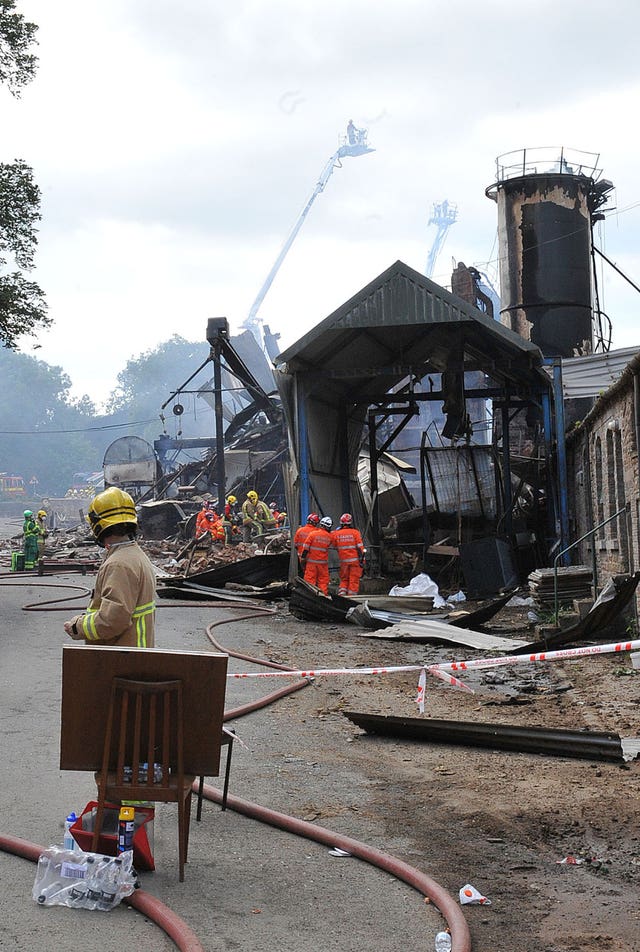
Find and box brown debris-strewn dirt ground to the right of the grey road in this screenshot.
[248,609,640,952]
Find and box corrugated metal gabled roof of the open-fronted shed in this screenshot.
[276,261,549,399]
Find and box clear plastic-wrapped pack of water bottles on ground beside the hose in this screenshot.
[32,846,138,912]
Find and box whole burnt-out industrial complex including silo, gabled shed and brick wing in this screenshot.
[95,141,640,616]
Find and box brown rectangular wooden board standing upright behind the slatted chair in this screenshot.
[60,645,228,777]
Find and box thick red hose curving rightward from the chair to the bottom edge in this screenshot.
[194,784,471,952]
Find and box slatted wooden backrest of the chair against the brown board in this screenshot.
[102,677,184,800]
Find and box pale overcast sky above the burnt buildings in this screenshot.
[7,0,640,401]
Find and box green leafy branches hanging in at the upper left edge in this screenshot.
[0,0,51,348]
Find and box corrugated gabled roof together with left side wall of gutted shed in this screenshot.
[275,261,550,540]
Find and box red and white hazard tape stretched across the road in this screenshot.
[227,640,640,714]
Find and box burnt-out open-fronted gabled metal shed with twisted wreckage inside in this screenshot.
[276,261,553,589]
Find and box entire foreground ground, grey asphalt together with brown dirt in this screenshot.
[0,512,640,952]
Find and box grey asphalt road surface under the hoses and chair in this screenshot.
[0,540,450,952]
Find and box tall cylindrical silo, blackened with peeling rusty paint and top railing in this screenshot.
[486,148,613,357]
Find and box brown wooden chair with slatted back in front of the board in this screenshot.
[91,678,195,882]
